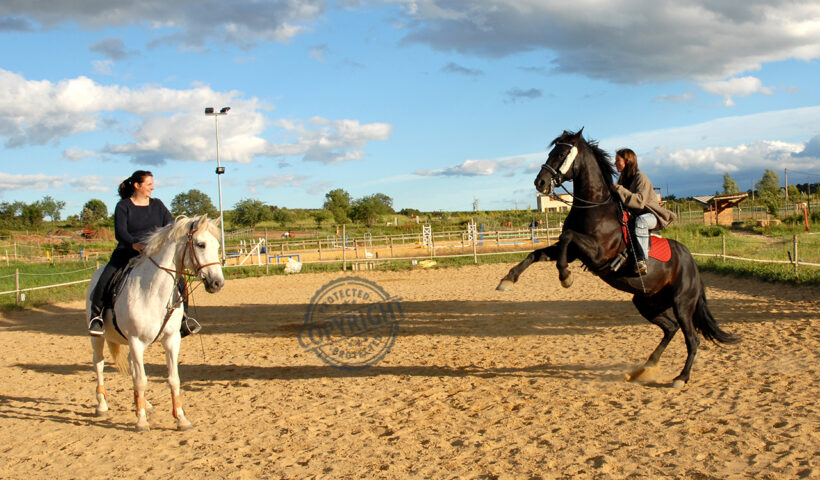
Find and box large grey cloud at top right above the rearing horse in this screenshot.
[396,0,820,83]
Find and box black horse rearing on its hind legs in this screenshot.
[498,129,738,388]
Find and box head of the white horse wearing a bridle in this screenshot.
[182,215,225,293]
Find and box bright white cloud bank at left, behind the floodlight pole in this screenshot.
[0,69,392,165]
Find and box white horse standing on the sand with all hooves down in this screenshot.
[86,215,225,431]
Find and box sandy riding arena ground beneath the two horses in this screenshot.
[0,264,820,480]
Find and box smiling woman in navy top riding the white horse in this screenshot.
[88,170,199,336]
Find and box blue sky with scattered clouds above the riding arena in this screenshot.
[0,0,820,216]
